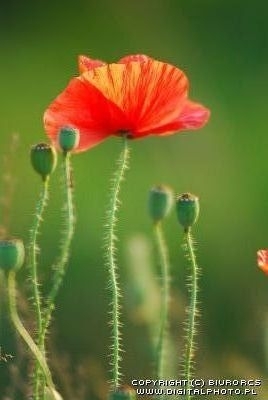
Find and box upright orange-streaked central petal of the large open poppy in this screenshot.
[82,59,188,138]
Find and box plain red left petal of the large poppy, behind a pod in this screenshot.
[44,78,129,152]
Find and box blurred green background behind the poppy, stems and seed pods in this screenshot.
[0,0,268,400]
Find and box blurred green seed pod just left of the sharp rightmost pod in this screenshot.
[149,185,173,223]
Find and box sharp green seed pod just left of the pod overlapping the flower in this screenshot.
[31,143,57,181]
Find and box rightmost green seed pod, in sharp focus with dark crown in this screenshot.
[176,193,199,232]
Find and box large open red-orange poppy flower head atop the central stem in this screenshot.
[44,55,210,151]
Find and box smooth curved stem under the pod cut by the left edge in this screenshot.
[8,271,56,400]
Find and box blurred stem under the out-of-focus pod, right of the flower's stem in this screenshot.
[154,222,170,379]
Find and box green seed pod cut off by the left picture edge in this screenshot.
[0,239,25,271]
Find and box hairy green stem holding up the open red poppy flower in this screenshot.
[105,136,129,391]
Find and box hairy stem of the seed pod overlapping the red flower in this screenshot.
[40,153,75,393]
